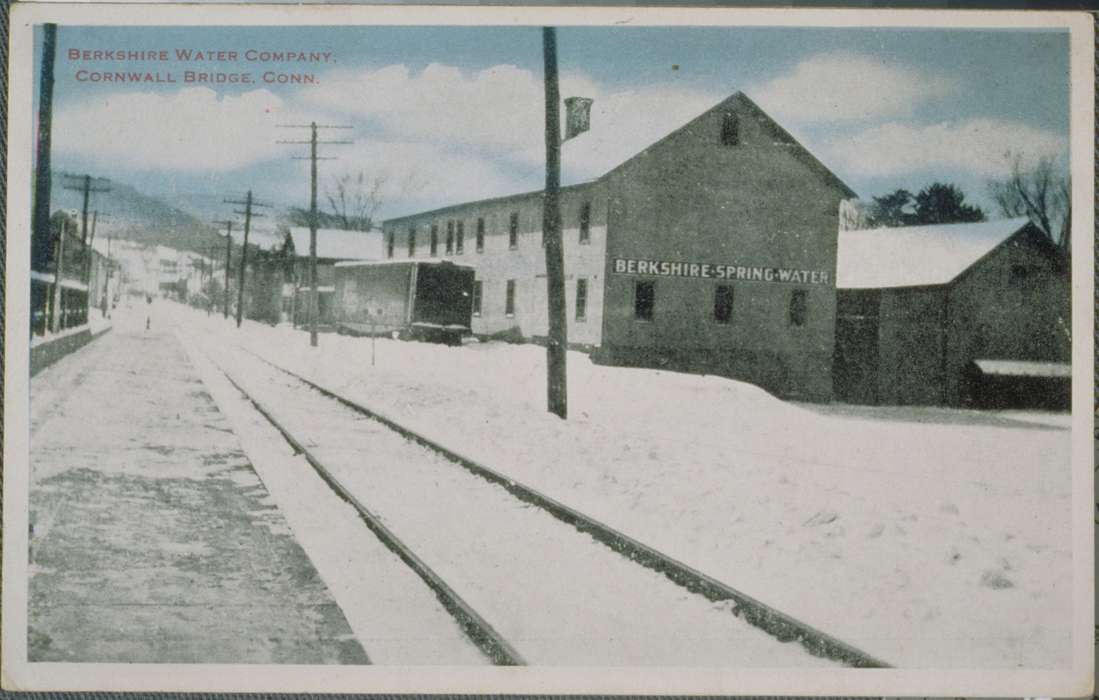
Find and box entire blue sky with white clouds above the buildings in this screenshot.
[38,26,1069,235]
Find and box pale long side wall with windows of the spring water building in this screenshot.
[385,182,607,346]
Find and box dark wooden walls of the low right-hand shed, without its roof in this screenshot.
[835,226,1072,405]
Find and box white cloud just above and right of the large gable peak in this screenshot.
[748,52,958,123]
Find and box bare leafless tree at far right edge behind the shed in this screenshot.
[988,152,1073,253]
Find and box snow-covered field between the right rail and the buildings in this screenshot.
[162,302,1072,668]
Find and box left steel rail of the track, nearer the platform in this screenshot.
[207,349,526,666]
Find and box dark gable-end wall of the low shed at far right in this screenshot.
[945,227,1072,404]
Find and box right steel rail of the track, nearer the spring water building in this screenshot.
[237,345,891,668]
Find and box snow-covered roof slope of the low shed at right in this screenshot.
[835,218,1028,289]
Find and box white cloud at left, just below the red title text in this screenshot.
[54,87,318,173]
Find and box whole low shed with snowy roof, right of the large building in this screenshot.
[833,219,1072,407]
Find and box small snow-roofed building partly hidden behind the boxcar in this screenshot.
[289,226,382,326]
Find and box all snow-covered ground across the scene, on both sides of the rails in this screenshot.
[32,301,1072,668]
